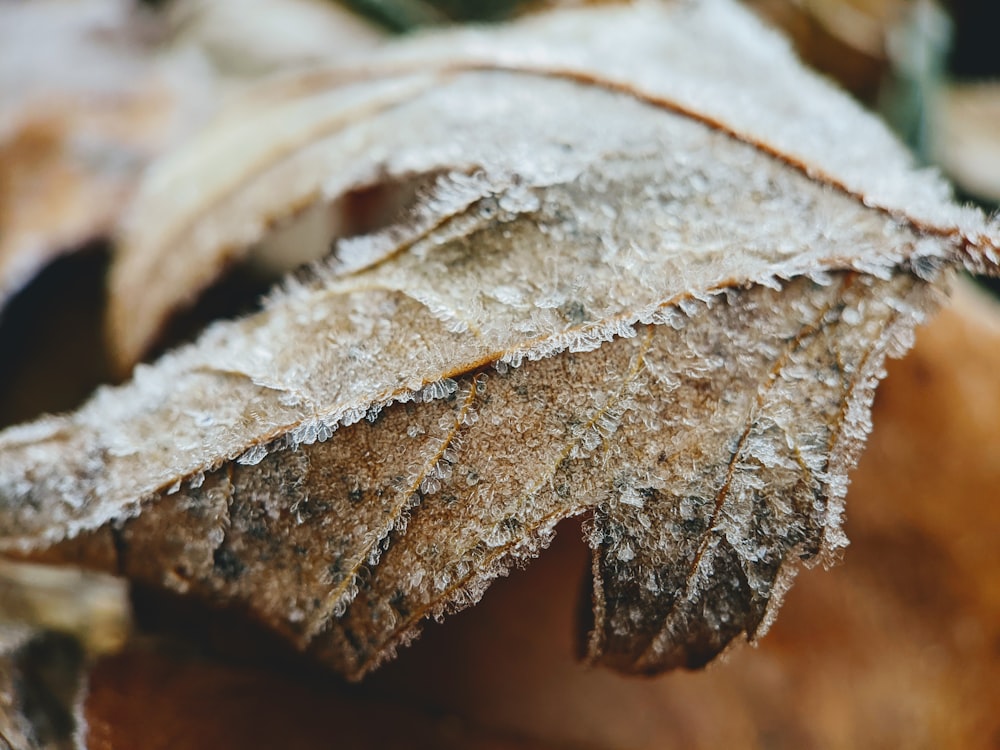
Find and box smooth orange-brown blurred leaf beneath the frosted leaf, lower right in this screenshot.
[363,285,1000,750]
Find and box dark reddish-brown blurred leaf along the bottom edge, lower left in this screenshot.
[81,647,549,750]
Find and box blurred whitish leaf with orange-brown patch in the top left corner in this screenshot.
[0,0,215,307]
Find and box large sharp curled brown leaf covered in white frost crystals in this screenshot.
[0,0,998,677]
